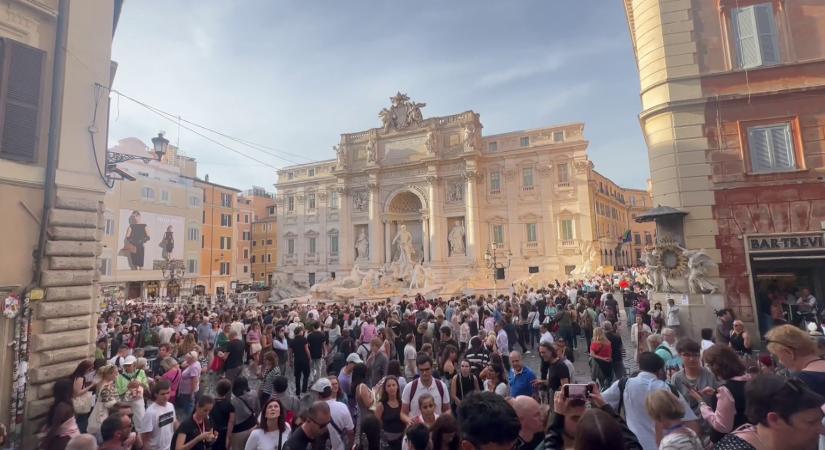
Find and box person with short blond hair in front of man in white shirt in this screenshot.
[645,390,704,450]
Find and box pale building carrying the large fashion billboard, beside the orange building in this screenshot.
[97,138,203,299]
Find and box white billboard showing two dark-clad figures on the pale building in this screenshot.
[118,209,186,270]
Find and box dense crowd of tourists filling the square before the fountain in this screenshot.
[40,272,825,450]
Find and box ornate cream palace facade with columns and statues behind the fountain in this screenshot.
[276,93,626,285]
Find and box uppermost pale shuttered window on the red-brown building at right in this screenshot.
[731,3,780,69]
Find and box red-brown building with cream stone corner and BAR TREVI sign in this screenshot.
[625,0,825,331]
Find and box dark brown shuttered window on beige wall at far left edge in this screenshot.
[0,39,46,162]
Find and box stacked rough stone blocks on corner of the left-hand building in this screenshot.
[24,193,102,440]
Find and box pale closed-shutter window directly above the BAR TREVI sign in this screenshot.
[748,123,796,173]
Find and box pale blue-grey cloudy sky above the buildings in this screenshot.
[109,0,649,190]
